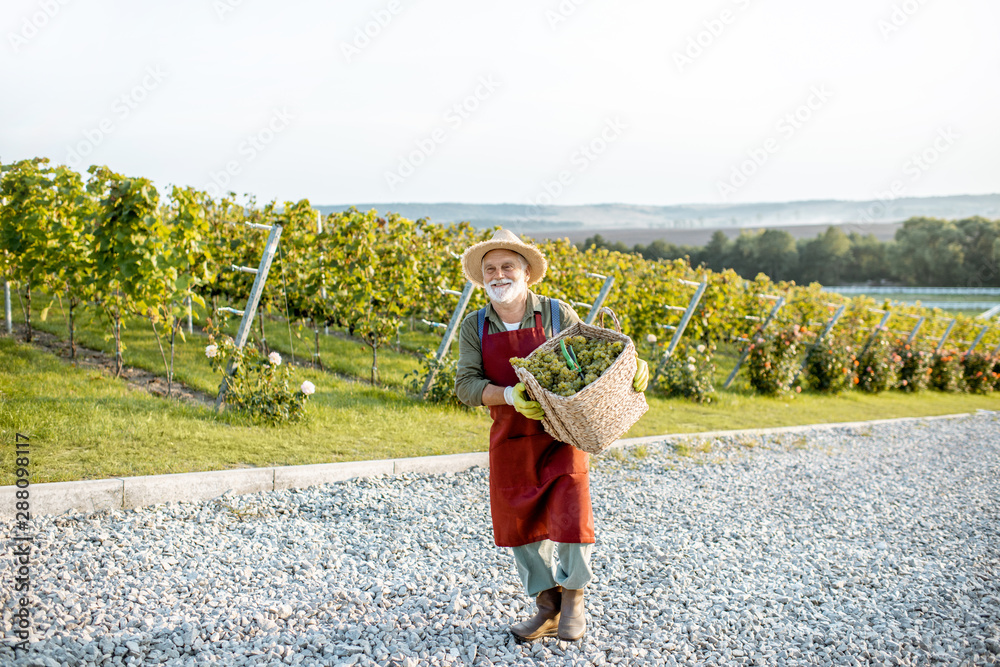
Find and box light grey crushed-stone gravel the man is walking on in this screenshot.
[0,412,1000,665]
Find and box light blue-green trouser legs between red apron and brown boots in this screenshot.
[511,540,594,597]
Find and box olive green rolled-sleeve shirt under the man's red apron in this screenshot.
[455,290,581,405]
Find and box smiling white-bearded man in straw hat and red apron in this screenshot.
[455,229,649,641]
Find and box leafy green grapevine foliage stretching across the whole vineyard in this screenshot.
[0,158,1000,388]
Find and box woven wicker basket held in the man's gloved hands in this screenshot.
[514,308,649,454]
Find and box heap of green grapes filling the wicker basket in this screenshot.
[510,336,625,396]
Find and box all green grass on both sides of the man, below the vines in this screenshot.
[0,302,1000,485]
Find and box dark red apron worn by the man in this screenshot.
[482,313,594,547]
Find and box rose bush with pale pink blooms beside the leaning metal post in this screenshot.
[205,330,316,426]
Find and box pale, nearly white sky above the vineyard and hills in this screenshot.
[0,0,1000,205]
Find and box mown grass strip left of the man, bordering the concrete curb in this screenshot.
[0,338,490,485]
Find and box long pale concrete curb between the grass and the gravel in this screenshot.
[0,412,972,521]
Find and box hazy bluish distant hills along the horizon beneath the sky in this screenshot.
[317,194,1000,237]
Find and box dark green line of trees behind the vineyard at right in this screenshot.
[579,216,1000,287]
